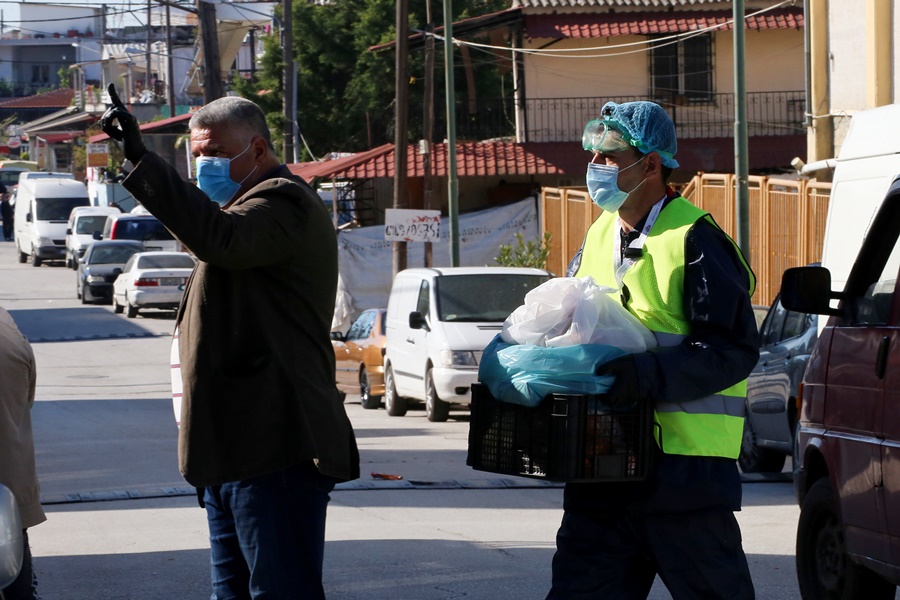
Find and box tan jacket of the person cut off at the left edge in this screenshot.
[0,308,47,529]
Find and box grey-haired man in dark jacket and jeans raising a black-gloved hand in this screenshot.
[101,85,359,600]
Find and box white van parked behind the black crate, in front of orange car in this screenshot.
[384,267,553,421]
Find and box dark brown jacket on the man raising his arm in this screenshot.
[124,153,359,487]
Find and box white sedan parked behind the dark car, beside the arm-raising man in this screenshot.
[112,252,196,319]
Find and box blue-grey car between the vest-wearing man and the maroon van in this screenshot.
[738,297,818,473]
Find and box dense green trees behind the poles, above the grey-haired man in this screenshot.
[235,0,510,160]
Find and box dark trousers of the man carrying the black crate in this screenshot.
[547,510,754,600]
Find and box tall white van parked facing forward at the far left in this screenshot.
[15,177,90,267]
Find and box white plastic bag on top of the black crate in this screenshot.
[500,277,657,353]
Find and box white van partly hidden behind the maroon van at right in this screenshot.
[819,104,900,300]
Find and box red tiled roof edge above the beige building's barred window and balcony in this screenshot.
[525,7,803,39]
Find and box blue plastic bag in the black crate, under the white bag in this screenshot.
[478,335,625,407]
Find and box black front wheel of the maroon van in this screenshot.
[797,477,897,600]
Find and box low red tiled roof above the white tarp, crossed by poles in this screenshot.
[288,142,587,181]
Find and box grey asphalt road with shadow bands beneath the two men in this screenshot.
[0,243,816,600]
